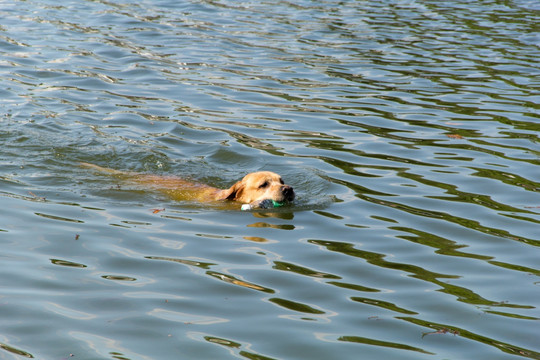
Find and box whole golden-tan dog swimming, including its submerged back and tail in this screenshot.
[81,163,295,204]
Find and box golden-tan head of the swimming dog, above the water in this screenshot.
[219,171,294,203]
